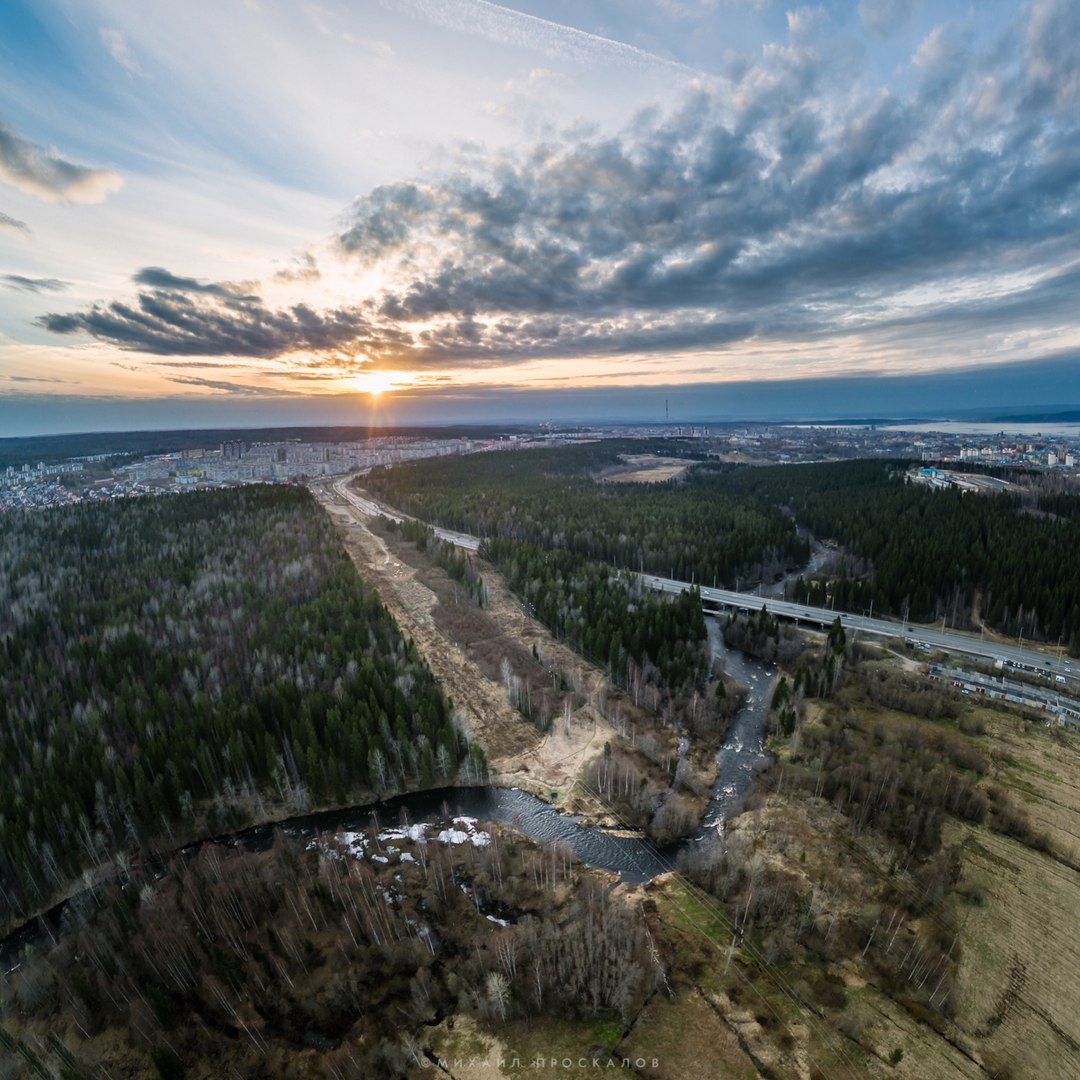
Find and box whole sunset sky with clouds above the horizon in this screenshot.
[0,0,1080,437]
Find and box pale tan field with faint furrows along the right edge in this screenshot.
[947,710,1080,1080]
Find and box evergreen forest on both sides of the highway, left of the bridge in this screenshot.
[366,440,786,704]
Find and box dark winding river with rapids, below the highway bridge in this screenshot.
[0,617,777,974]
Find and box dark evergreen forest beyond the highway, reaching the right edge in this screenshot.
[692,461,1080,656]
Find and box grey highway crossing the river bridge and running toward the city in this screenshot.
[313,477,1080,685]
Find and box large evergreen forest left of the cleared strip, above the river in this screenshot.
[0,485,473,924]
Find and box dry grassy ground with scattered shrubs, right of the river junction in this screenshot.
[619,682,1080,1080]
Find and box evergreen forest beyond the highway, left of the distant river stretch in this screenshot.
[366,440,810,586]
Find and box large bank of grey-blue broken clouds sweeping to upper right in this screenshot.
[29,0,1080,384]
